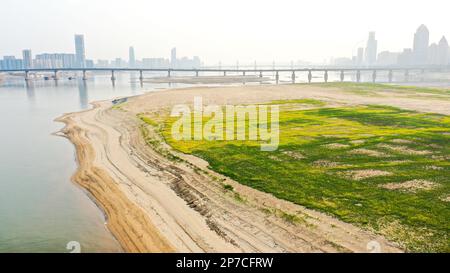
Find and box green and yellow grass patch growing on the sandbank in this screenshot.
[141,93,450,252]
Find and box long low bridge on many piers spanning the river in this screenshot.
[0,65,450,83]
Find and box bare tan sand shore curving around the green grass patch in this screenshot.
[58,85,450,252]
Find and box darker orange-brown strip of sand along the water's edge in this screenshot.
[57,105,173,252]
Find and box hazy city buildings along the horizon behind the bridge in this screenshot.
[0,24,450,69]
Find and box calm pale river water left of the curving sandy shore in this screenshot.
[0,74,179,252]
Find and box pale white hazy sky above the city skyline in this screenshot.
[0,0,450,64]
